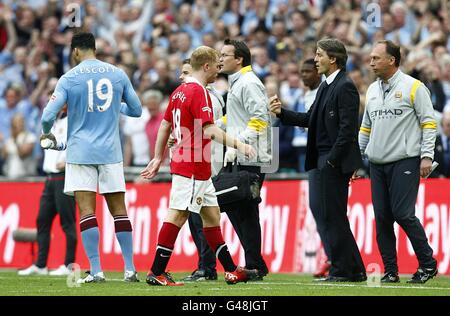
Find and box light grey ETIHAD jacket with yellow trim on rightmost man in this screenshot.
[359,70,437,164]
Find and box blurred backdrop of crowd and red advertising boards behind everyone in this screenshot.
[0,0,450,292]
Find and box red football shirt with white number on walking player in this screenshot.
[164,77,214,180]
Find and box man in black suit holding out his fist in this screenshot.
[270,39,367,282]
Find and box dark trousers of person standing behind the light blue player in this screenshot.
[36,173,77,268]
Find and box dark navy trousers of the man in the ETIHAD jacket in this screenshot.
[370,157,436,272]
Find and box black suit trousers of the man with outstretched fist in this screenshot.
[318,155,366,278]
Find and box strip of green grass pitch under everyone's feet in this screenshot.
[0,270,450,296]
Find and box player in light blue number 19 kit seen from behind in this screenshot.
[41,33,142,283]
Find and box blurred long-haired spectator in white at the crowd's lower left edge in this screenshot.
[2,113,37,179]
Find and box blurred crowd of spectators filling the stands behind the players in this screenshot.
[0,0,450,178]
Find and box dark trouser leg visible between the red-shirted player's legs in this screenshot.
[189,212,216,271]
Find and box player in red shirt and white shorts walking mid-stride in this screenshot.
[141,46,257,286]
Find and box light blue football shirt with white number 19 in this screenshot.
[41,59,142,164]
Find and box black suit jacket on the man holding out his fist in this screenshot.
[278,70,363,173]
